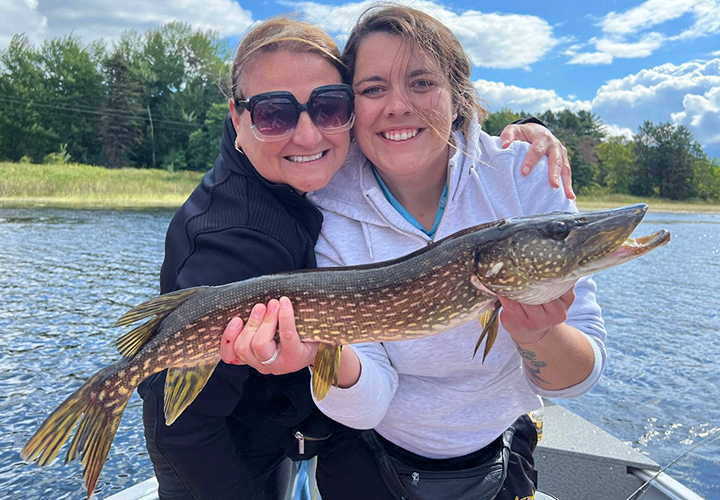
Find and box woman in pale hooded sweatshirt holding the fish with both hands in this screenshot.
[223,6,606,500]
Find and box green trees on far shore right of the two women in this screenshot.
[483,109,720,200]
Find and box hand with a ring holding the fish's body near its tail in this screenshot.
[220,297,319,375]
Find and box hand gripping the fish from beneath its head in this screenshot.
[498,289,575,344]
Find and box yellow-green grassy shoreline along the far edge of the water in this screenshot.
[0,162,720,212]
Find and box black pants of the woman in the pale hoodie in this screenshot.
[317,415,537,500]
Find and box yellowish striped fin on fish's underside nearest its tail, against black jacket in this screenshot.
[165,360,218,425]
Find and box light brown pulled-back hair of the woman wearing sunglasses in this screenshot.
[230,17,345,105]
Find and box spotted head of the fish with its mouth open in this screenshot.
[472,204,670,304]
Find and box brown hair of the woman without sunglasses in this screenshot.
[342,4,487,135]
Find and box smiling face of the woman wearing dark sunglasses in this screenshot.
[229,50,350,193]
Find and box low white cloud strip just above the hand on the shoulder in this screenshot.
[475,80,590,113]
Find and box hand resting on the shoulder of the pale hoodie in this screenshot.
[500,123,575,200]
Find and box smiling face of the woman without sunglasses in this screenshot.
[353,33,453,183]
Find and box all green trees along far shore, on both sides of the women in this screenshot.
[0,22,720,200]
